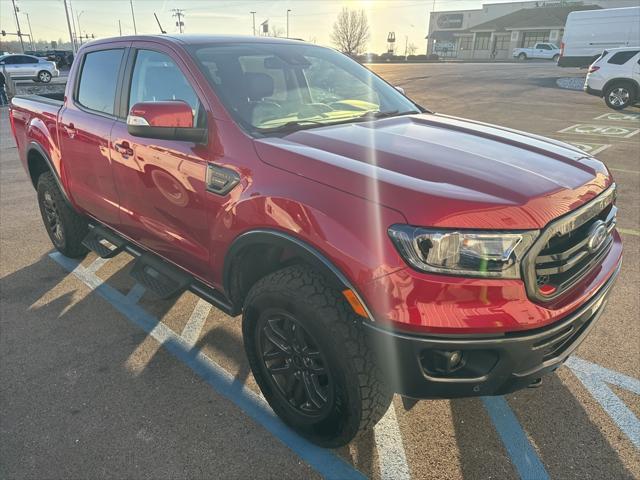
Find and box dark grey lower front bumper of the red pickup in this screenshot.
[365,266,620,398]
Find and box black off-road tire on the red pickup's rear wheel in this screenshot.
[37,172,88,258]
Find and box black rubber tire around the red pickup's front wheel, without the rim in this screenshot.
[242,265,393,448]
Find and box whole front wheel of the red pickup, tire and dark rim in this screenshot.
[242,265,393,447]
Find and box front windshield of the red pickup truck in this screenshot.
[192,43,420,134]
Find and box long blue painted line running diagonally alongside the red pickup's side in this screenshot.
[49,252,366,480]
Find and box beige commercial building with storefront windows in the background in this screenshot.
[427,0,638,60]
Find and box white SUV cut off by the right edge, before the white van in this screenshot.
[584,47,640,110]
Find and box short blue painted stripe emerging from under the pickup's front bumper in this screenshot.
[482,397,549,480]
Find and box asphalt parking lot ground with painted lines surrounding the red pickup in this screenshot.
[0,63,640,479]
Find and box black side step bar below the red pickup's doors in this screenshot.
[82,226,240,316]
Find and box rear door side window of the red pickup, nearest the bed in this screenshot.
[77,49,124,115]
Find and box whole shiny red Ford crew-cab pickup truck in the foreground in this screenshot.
[10,35,622,446]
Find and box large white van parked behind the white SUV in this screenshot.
[558,7,640,67]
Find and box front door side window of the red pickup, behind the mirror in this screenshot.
[129,50,200,123]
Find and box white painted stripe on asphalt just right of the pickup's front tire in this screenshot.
[373,402,411,480]
